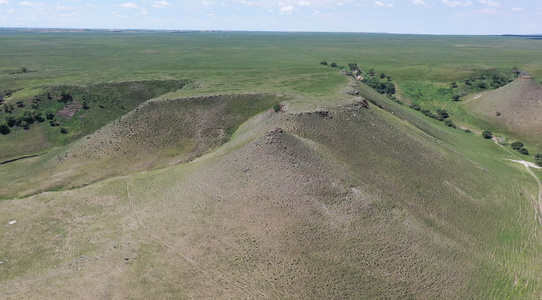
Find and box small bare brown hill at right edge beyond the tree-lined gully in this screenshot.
[464,77,542,149]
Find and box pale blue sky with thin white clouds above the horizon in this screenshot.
[0,0,542,35]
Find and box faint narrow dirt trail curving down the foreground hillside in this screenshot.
[126,177,260,299]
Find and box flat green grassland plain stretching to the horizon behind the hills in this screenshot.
[0,29,542,95]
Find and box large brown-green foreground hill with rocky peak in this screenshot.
[0,92,542,299]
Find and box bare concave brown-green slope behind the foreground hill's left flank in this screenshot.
[0,95,284,197]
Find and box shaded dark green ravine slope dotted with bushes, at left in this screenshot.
[0,80,189,160]
